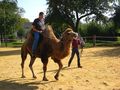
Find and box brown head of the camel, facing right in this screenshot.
[61,28,78,41]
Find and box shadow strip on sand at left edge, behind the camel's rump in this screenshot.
[0,50,21,56]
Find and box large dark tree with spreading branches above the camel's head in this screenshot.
[46,0,116,32]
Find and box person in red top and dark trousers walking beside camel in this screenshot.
[68,37,82,68]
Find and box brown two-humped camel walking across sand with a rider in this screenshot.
[21,25,77,81]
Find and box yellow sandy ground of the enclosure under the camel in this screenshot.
[0,47,120,90]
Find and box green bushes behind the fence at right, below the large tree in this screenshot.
[79,22,119,41]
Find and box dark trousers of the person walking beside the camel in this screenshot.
[68,48,80,67]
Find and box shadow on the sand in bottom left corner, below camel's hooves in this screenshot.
[0,79,56,90]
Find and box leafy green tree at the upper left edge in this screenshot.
[0,0,24,46]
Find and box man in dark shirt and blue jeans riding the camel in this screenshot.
[32,12,45,56]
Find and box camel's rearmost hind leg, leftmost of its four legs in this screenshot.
[21,47,27,78]
